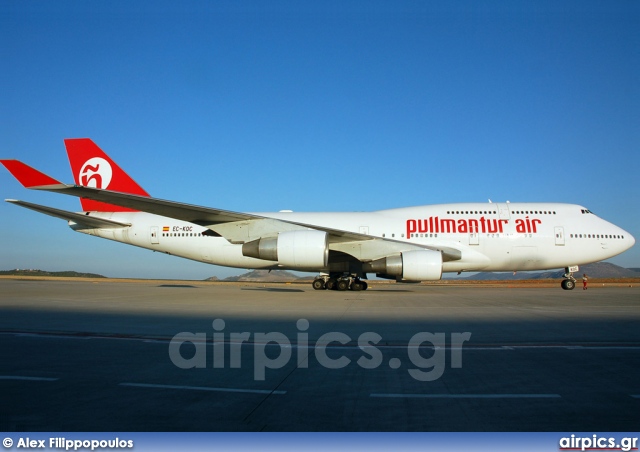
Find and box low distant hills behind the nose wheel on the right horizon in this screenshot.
[459,262,640,281]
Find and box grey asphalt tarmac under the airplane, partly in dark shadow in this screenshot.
[0,279,640,432]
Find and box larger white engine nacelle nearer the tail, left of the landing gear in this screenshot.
[242,230,329,270]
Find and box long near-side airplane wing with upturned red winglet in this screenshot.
[1,160,461,260]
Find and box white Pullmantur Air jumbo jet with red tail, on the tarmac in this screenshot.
[0,138,635,290]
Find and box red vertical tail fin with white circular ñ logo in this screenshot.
[64,138,149,212]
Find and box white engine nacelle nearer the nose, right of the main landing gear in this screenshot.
[363,250,442,281]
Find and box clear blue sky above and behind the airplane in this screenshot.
[0,0,640,279]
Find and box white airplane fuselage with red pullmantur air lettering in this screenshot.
[70,203,635,272]
